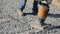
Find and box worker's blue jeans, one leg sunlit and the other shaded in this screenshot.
[18,0,38,11]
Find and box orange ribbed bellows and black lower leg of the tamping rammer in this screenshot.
[38,5,51,26]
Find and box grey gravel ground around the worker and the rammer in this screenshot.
[0,0,60,34]
